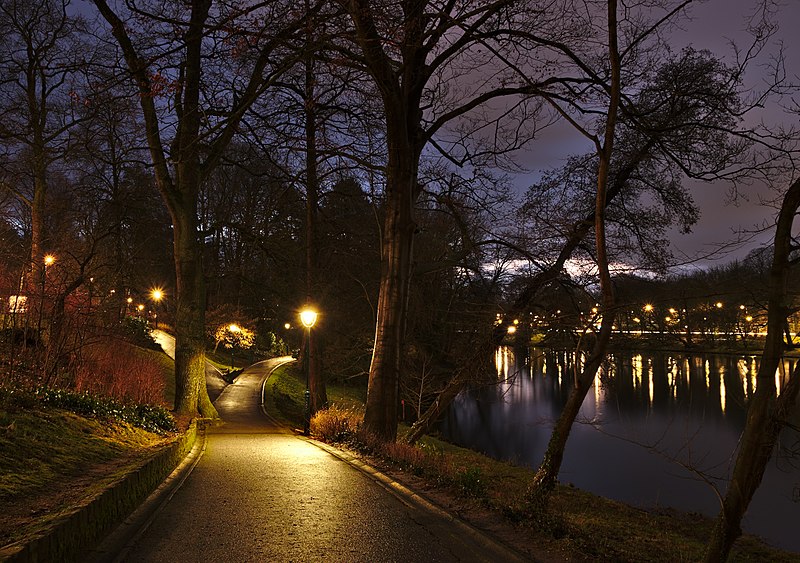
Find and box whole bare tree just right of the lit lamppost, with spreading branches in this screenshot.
[338,0,568,441]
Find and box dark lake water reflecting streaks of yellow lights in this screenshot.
[441,348,800,552]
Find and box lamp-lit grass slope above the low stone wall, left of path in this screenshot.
[0,408,174,545]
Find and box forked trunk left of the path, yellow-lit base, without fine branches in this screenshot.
[95,0,218,418]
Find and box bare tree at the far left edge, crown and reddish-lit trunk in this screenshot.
[0,0,89,296]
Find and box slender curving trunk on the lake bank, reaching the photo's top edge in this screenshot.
[530,0,620,501]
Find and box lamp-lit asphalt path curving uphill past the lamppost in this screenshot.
[93,338,524,563]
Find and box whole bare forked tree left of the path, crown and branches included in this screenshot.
[89,0,304,417]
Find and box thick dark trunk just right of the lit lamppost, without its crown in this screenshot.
[340,0,427,441]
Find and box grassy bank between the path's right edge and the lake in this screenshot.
[267,364,800,562]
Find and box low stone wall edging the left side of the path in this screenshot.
[0,422,197,563]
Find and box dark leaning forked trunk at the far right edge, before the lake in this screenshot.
[706,180,800,562]
